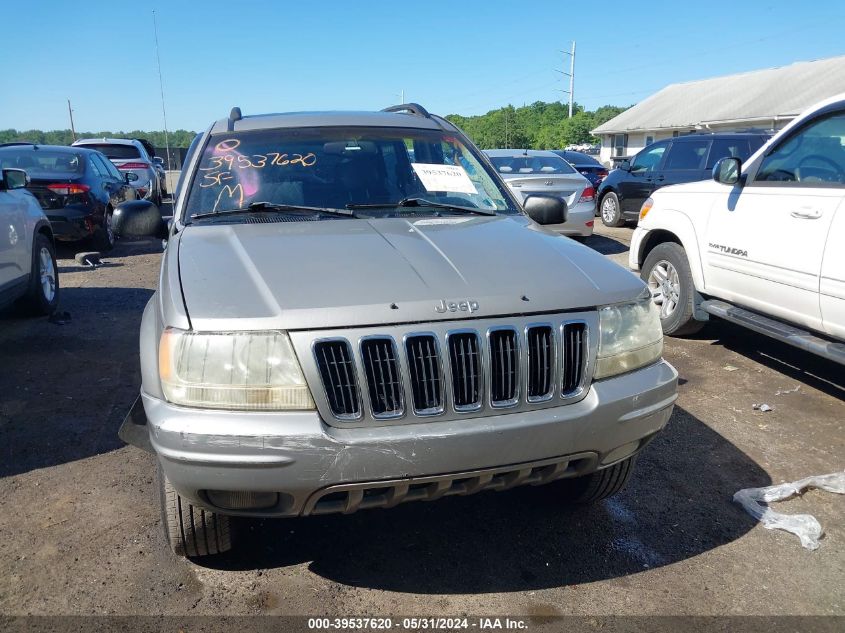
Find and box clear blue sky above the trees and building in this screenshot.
[0,0,845,131]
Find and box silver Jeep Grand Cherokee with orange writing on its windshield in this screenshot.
[114,104,677,557]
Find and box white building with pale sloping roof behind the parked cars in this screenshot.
[592,56,845,163]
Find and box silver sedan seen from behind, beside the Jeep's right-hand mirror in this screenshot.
[484,149,596,238]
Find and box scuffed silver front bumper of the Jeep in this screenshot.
[142,361,678,516]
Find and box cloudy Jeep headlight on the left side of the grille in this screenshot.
[158,328,314,411]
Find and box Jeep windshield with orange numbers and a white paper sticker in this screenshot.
[184,127,519,221]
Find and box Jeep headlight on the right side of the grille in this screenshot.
[593,291,663,379]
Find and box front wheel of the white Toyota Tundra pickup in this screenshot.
[640,242,705,336]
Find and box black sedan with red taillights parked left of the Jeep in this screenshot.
[0,144,137,251]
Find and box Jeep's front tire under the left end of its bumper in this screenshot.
[156,464,232,558]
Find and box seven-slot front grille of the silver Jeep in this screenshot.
[304,312,597,424]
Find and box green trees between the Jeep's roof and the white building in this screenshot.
[446,101,628,149]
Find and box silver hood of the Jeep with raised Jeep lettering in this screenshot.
[171,216,643,330]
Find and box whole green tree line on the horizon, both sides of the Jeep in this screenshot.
[0,101,627,149]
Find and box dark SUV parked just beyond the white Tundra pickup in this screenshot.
[596,132,771,226]
